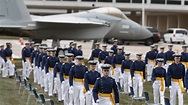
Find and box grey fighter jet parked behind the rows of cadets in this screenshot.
[0,0,152,47]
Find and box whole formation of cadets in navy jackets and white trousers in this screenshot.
[0,40,188,105]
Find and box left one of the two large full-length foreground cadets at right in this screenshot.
[151,58,166,105]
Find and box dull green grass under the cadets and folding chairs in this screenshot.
[0,60,188,105]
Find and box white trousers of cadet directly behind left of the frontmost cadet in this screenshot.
[85,88,95,105]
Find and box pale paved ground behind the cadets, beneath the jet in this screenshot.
[0,40,182,59]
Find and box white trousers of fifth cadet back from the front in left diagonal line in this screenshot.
[54,73,62,101]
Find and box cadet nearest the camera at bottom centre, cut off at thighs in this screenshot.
[93,64,119,105]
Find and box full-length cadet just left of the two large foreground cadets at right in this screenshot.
[131,54,145,97]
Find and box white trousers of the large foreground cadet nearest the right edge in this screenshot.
[170,81,184,105]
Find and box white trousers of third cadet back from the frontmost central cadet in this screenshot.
[73,81,85,105]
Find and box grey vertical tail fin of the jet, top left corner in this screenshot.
[0,0,31,22]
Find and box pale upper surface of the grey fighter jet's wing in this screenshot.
[34,16,109,26]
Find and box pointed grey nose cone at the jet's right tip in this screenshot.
[140,26,153,39]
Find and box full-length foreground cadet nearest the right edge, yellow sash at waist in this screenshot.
[166,54,185,105]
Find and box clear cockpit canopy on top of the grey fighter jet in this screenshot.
[89,7,127,19]
